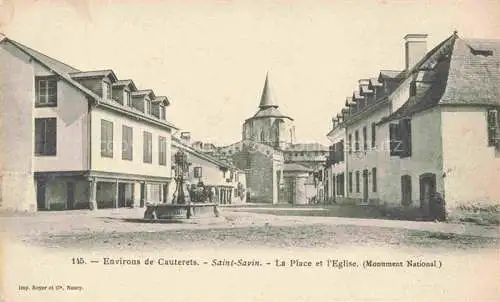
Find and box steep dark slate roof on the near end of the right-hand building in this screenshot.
[381,35,500,123]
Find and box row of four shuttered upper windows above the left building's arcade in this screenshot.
[101,119,167,166]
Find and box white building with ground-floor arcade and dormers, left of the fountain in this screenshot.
[0,37,178,211]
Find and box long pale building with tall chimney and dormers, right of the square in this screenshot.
[328,33,500,219]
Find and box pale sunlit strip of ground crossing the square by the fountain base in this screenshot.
[0,207,500,238]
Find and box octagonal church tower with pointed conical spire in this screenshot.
[243,73,295,149]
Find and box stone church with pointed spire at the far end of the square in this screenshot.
[193,74,328,204]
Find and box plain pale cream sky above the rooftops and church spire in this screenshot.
[0,0,500,144]
